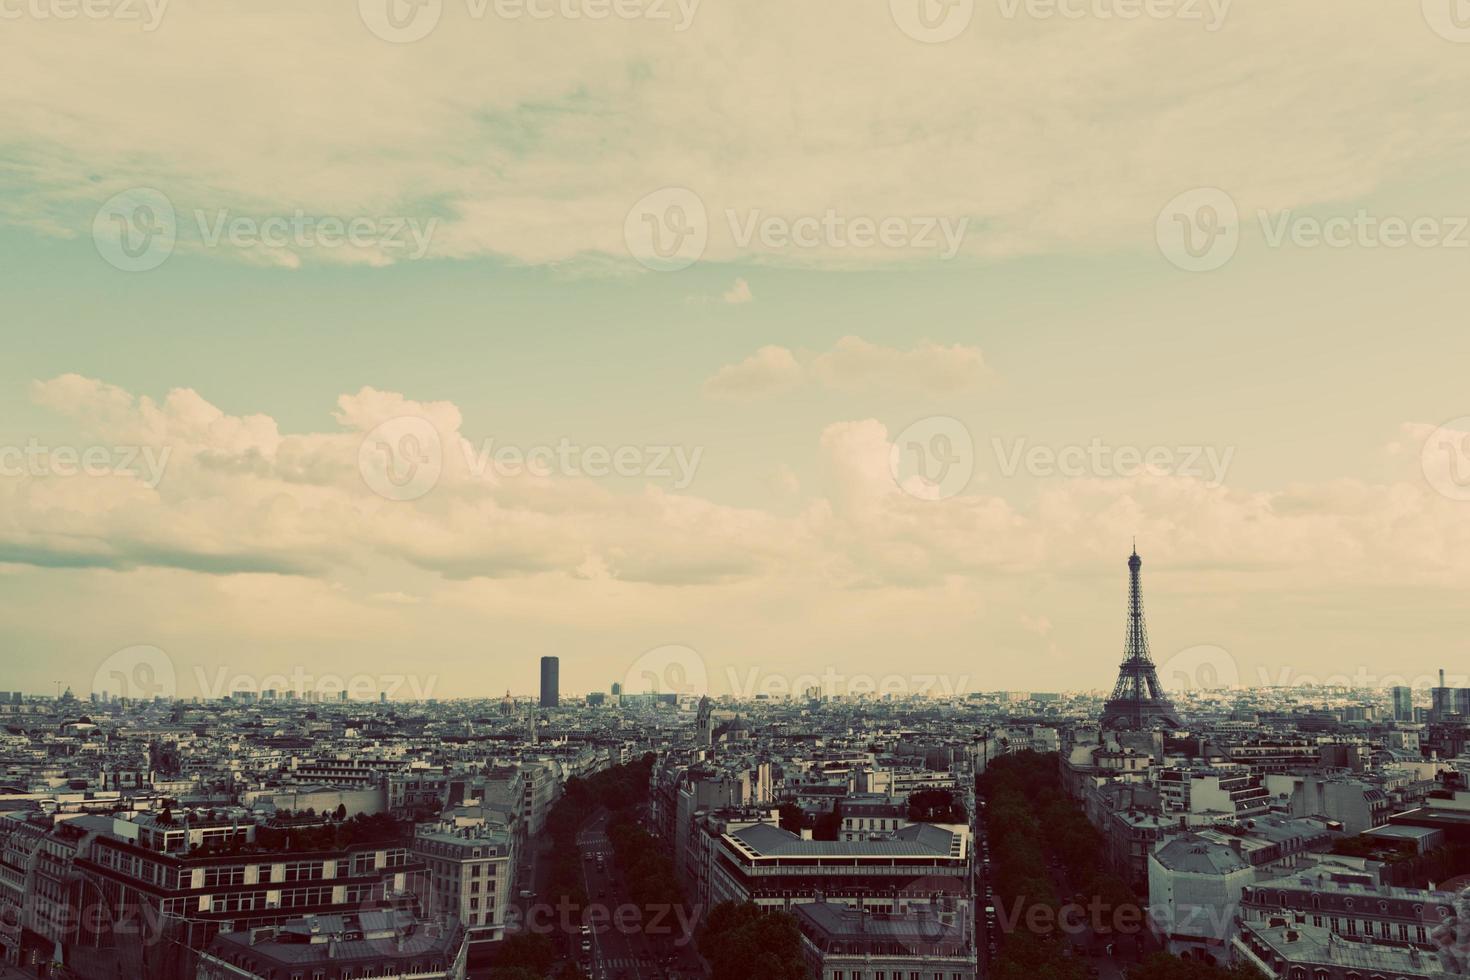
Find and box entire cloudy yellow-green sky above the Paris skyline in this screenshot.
[0,0,1470,699]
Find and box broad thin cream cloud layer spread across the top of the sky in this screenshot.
[0,0,1470,264]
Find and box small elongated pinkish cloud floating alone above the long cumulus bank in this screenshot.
[704,336,986,398]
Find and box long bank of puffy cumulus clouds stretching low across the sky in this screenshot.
[14,379,1470,602]
